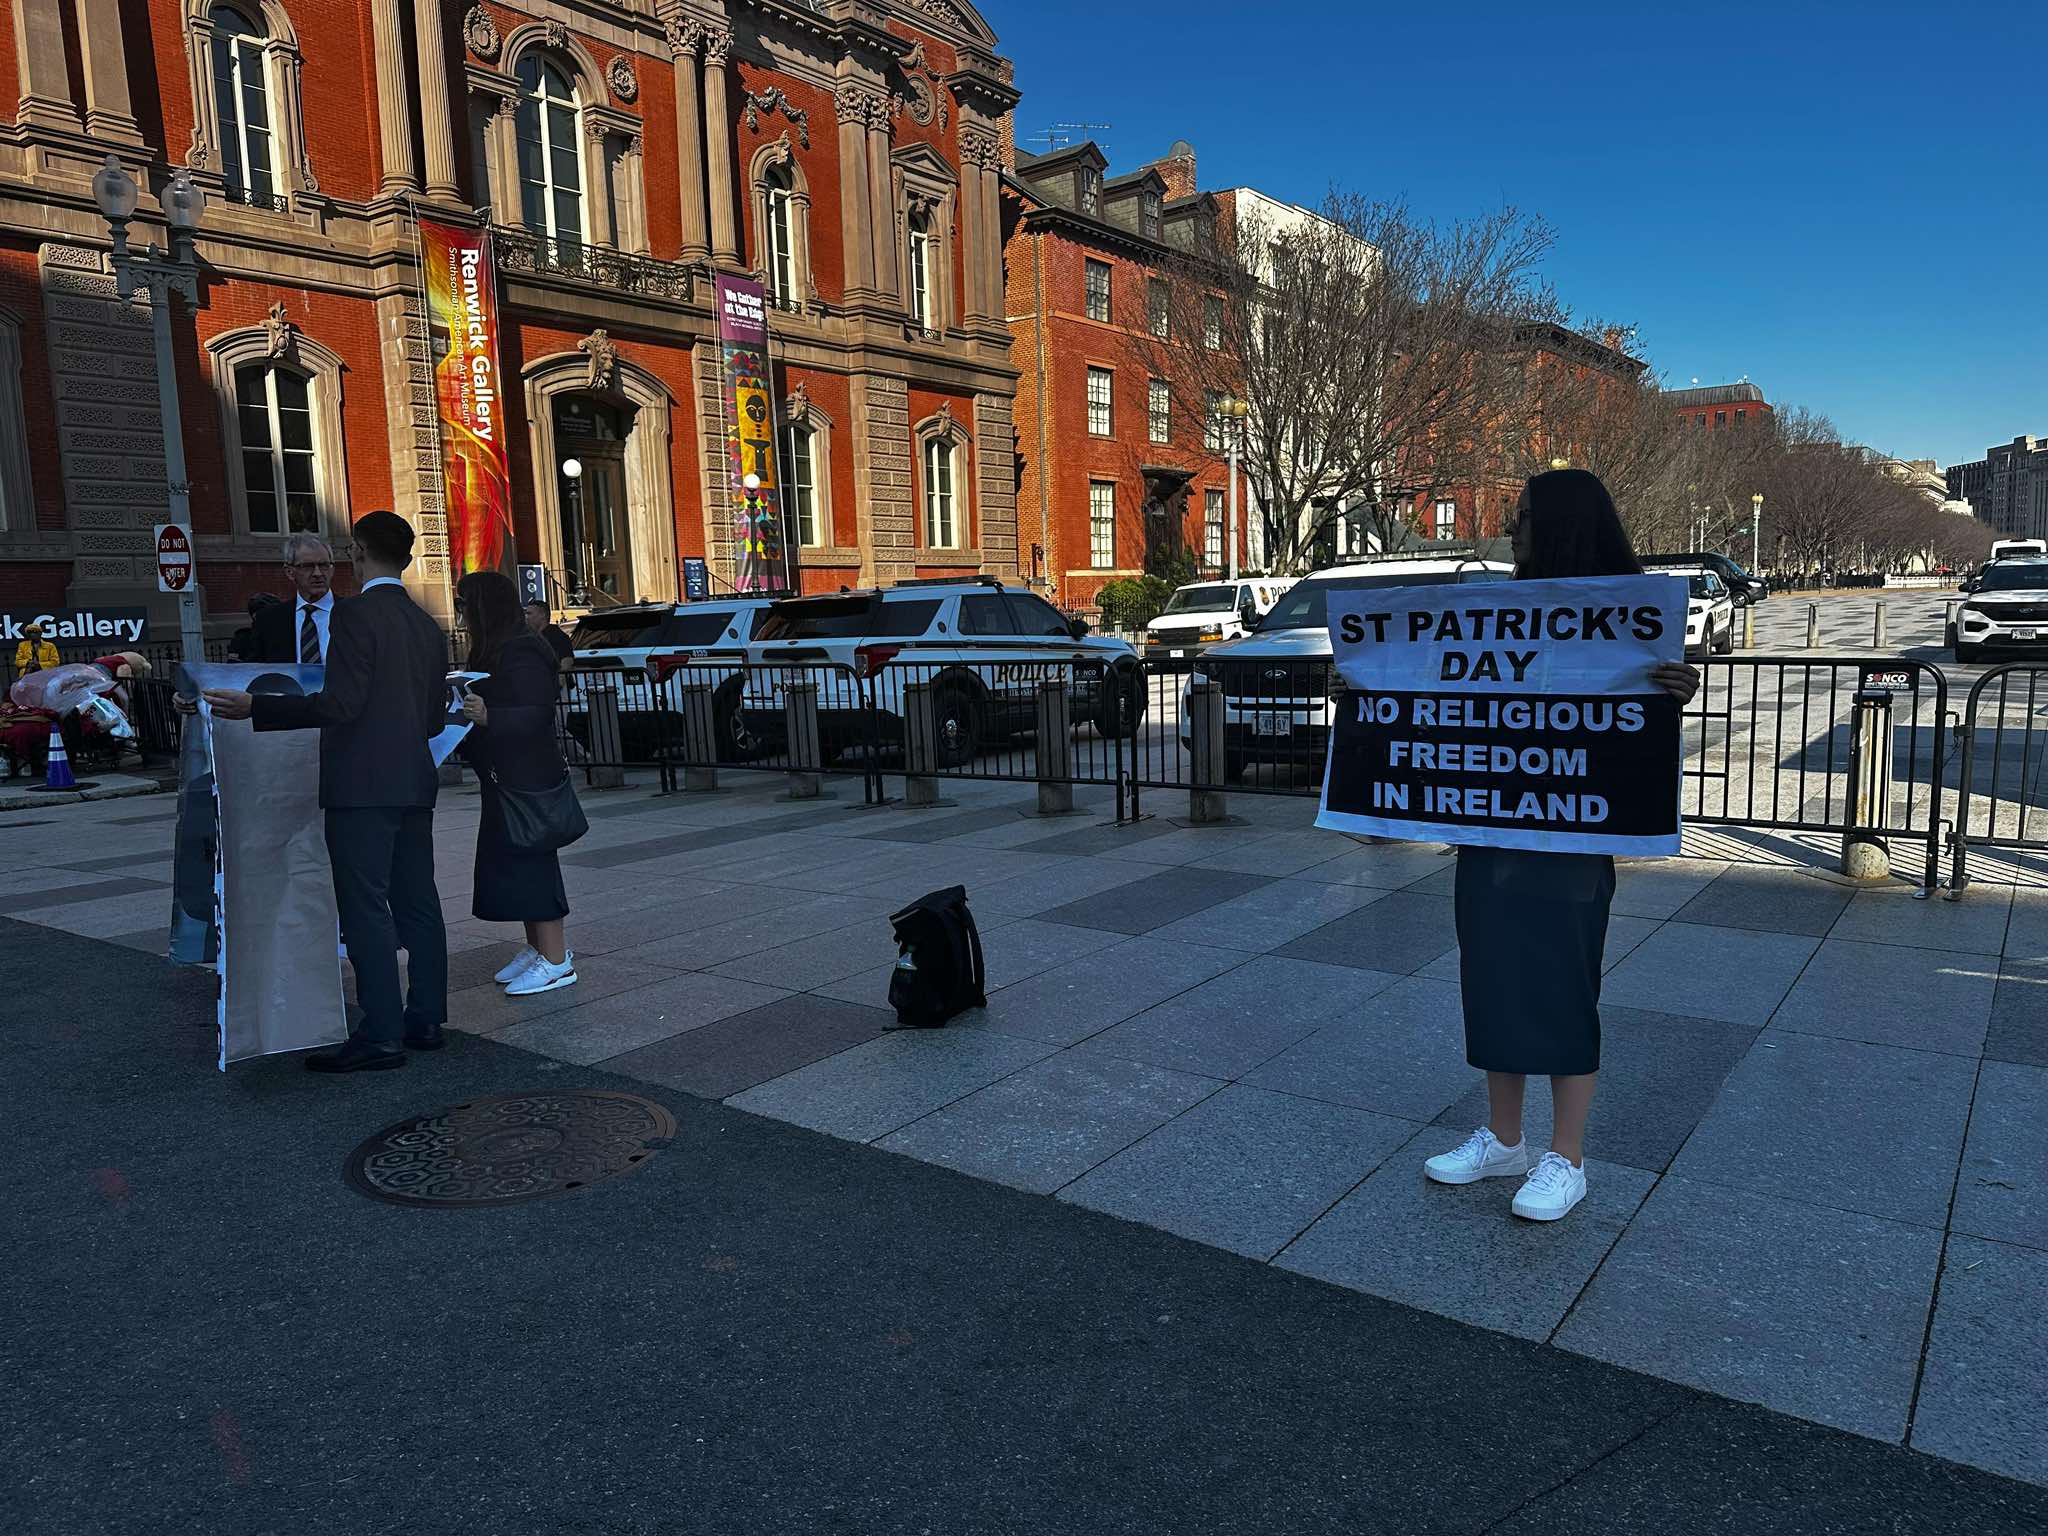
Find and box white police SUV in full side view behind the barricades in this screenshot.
[739,575,1145,768]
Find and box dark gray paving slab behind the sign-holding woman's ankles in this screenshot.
[1438,1008,1757,1174]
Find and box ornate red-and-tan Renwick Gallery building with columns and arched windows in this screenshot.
[0,0,1020,637]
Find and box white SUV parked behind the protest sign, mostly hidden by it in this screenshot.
[1180,553,1513,784]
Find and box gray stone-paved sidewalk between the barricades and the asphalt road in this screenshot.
[0,776,2048,1483]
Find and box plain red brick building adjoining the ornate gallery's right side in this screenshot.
[1004,143,1243,608]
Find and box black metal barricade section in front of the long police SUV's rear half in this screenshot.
[647,651,887,805]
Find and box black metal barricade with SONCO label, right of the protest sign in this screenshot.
[1679,655,1948,891]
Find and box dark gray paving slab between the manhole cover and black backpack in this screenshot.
[604,995,895,1098]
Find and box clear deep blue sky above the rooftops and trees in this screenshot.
[983,0,2048,465]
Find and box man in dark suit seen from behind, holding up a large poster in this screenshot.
[207,512,449,1071]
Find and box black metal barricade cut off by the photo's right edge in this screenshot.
[1950,662,2048,893]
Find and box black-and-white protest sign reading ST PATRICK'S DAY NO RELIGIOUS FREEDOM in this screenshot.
[1317,575,1686,854]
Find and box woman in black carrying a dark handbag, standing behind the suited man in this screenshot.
[455,571,575,997]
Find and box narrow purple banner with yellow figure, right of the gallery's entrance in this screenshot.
[715,276,797,592]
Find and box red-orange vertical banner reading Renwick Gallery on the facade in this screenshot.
[420,219,512,578]
